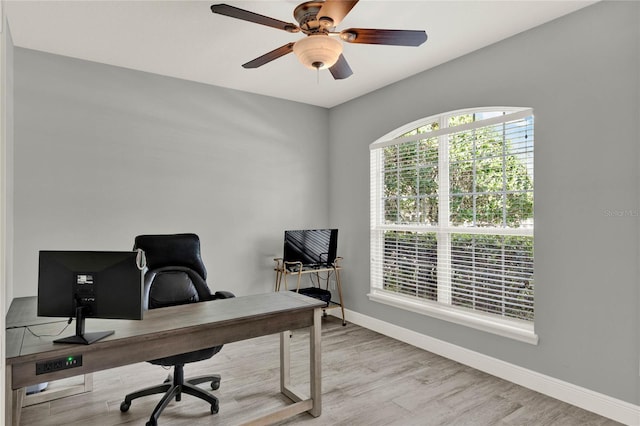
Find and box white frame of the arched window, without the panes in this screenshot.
[368,107,538,345]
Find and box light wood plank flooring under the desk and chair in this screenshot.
[21,317,618,426]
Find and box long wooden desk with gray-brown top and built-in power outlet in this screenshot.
[5,292,324,426]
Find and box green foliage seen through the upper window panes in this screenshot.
[384,115,533,227]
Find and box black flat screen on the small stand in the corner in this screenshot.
[282,229,338,268]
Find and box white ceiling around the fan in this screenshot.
[5,0,595,107]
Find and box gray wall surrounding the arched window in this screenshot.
[329,2,640,404]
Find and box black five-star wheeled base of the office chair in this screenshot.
[120,365,220,426]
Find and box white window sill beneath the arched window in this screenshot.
[368,289,538,345]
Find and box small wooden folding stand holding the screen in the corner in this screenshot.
[273,257,347,325]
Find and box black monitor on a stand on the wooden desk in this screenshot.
[38,250,143,345]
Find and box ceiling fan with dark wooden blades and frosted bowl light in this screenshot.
[211,0,427,80]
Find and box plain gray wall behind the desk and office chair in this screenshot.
[14,48,329,297]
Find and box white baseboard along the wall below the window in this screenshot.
[332,309,640,426]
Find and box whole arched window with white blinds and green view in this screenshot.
[369,107,537,343]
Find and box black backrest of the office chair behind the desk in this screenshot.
[133,234,212,309]
